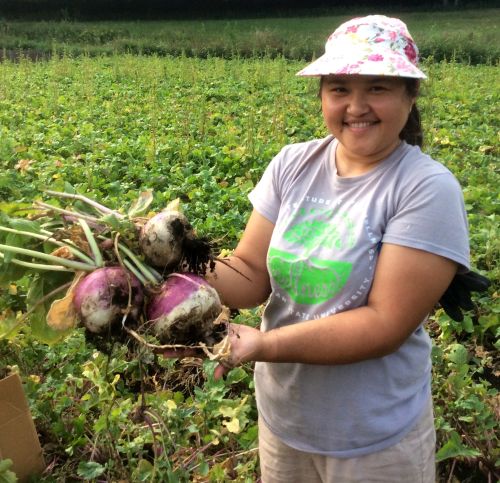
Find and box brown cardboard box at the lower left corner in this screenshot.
[0,374,45,482]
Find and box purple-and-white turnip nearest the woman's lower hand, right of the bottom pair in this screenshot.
[147,273,222,345]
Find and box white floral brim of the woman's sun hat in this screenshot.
[296,52,427,79]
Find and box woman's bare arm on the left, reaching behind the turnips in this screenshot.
[207,211,274,308]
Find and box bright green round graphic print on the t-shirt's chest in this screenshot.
[268,211,354,305]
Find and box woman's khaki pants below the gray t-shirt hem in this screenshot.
[259,401,436,483]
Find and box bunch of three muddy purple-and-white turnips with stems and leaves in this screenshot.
[0,191,228,356]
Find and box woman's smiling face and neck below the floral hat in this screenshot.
[321,75,415,175]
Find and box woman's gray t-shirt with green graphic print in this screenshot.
[249,136,469,458]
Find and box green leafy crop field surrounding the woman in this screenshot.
[0,10,500,483]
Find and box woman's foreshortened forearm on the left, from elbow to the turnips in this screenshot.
[206,256,271,309]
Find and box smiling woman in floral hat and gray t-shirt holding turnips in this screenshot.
[183,15,469,483]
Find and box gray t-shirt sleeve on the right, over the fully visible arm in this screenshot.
[382,171,470,268]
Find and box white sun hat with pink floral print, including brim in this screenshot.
[297,15,427,79]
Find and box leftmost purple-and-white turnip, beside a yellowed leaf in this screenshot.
[73,266,144,334]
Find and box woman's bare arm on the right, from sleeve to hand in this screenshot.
[225,244,457,364]
